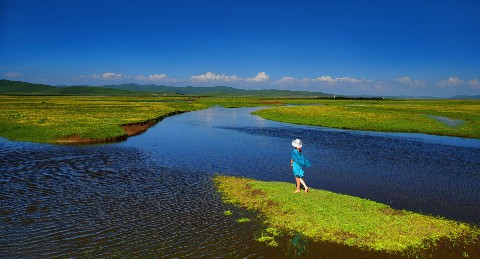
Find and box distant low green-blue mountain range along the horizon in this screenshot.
[0,80,333,97]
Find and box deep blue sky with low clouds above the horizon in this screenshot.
[0,0,480,97]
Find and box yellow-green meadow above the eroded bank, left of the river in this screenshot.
[0,96,207,143]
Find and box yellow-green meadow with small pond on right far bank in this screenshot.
[254,100,480,138]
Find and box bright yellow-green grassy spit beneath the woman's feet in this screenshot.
[214,176,480,253]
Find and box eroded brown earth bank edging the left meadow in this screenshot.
[53,110,186,145]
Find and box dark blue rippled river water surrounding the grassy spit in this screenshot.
[0,107,480,258]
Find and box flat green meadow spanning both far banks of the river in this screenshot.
[0,96,480,143]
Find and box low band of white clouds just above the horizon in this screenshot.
[73,72,474,96]
